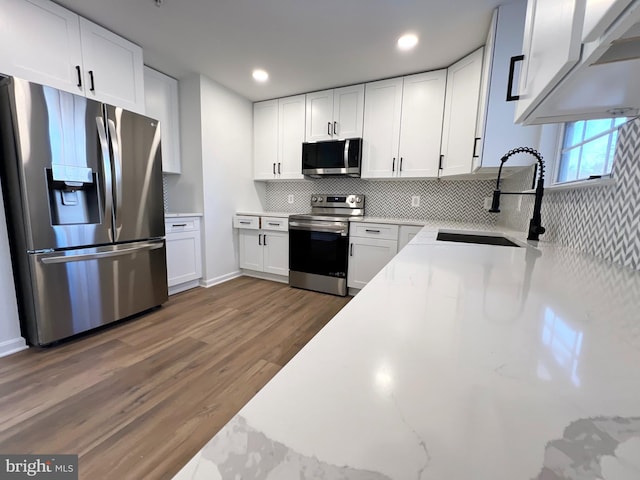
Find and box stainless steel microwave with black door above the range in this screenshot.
[302,138,362,178]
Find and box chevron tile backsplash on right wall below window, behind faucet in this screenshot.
[498,119,640,270]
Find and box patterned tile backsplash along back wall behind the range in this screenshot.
[266,178,497,225]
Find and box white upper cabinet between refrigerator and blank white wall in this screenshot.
[144,67,182,173]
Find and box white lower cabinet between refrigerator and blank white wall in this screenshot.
[165,217,202,295]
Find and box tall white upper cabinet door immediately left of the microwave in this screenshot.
[276,95,305,180]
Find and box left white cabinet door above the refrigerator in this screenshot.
[0,0,84,95]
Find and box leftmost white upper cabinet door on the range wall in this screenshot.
[253,100,278,180]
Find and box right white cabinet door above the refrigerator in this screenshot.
[80,18,145,113]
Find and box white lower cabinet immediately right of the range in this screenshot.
[347,223,398,289]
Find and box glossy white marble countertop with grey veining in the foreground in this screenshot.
[175,227,640,480]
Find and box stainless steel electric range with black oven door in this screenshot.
[289,194,364,296]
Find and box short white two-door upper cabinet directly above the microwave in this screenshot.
[305,85,364,142]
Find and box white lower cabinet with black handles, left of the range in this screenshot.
[234,215,289,277]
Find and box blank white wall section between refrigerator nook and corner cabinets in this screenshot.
[200,77,265,285]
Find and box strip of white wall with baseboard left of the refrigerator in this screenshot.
[0,183,26,357]
